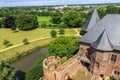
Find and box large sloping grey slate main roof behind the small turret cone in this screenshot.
[80,14,120,50]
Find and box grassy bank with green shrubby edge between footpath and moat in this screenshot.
[0,38,53,63]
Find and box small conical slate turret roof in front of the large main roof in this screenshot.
[91,30,113,51]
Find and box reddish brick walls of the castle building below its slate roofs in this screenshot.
[80,44,120,80]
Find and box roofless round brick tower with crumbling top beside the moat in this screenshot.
[43,56,60,80]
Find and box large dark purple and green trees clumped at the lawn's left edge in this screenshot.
[0,14,38,31]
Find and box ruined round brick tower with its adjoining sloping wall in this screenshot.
[43,54,81,80]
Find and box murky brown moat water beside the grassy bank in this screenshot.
[10,47,48,80]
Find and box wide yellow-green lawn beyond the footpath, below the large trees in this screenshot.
[0,28,76,50]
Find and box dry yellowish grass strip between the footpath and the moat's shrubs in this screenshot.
[0,38,53,60]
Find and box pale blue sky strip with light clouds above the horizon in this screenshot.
[0,0,120,6]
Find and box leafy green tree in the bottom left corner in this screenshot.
[0,60,16,80]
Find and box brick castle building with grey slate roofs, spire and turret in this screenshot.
[79,9,120,80]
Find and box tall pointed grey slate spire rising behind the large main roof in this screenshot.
[82,8,100,32]
